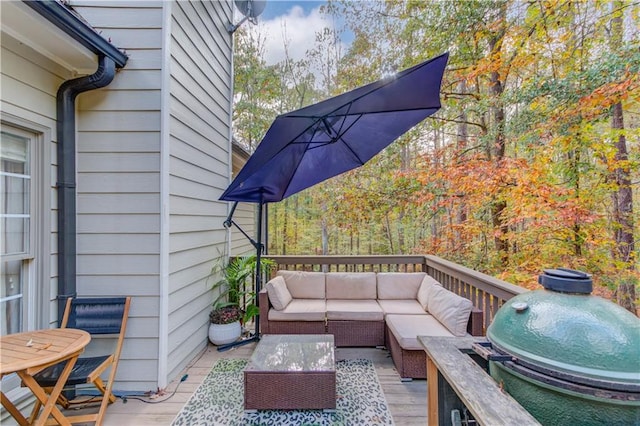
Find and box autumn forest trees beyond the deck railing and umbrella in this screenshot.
[233,0,640,313]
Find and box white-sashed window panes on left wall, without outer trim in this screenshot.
[0,124,37,334]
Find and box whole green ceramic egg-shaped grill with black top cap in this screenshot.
[487,268,640,425]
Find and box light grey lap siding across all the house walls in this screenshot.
[0,0,232,391]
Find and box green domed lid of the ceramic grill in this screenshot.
[487,270,640,389]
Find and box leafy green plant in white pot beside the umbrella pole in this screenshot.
[209,255,274,345]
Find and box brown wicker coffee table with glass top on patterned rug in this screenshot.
[244,334,336,410]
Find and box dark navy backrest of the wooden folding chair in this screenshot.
[66,297,126,334]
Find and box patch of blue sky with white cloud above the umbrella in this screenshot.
[236,0,348,65]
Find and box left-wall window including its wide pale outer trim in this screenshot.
[0,115,51,399]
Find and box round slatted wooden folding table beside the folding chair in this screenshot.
[0,328,91,425]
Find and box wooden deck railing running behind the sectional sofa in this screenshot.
[264,255,526,330]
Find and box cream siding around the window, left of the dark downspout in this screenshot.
[0,33,60,329]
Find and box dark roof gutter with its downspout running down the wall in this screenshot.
[25,0,127,321]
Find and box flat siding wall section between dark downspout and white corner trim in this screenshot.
[71,0,164,391]
